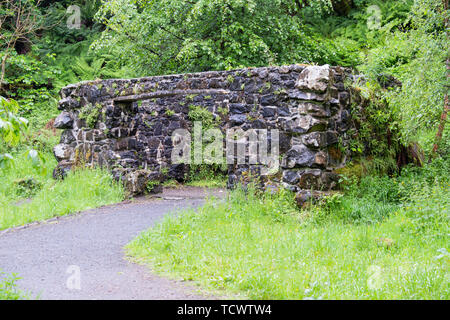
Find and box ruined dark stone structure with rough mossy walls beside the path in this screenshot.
[54,65,362,203]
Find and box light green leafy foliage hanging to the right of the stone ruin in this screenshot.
[360,0,448,150]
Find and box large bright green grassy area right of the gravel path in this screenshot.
[127,161,450,299]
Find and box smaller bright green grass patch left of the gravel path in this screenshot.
[0,154,124,230]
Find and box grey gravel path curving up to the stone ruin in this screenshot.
[0,188,225,299]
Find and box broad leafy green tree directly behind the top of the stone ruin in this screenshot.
[94,0,338,75]
